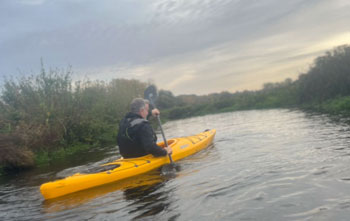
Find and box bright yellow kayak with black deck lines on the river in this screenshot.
[40,129,216,199]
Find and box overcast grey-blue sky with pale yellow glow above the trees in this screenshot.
[0,0,350,95]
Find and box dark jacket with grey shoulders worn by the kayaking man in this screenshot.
[117,112,167,158]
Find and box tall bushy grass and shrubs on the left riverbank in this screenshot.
[0,68,147,169]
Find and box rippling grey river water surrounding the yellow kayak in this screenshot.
[0,109,350,221]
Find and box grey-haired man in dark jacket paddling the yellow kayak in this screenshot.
[117,98,172,158]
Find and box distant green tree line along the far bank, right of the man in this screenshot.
[158,45,350,119]
